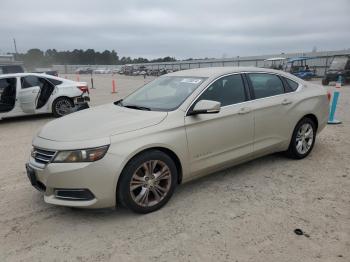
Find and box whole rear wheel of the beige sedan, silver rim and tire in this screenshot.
[287,118,316,159]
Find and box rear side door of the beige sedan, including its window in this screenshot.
[247,73,295,153]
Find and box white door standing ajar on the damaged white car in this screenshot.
[18,75,42,113]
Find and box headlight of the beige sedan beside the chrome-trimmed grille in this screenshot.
[52,146,109,163]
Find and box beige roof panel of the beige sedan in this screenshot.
[166,66,300,82]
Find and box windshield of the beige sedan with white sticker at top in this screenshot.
[115,76,206,111]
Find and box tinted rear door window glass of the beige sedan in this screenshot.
[248,74,284,99]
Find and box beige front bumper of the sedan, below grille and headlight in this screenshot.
[26,152,120,208]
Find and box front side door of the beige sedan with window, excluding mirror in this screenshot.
[185,74,254,176]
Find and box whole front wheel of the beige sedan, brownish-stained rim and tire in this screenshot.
[117,150,178,214]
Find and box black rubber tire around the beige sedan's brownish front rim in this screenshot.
[117,150,178,214]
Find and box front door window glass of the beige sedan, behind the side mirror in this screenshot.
[198,75,246,106]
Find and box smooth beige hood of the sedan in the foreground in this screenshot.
[38,104,167,141]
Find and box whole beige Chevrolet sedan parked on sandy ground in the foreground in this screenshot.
[26,67,329,213]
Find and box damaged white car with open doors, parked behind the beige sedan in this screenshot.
[0,73,90,120]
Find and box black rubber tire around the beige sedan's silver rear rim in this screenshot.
[286,117,317,159]
